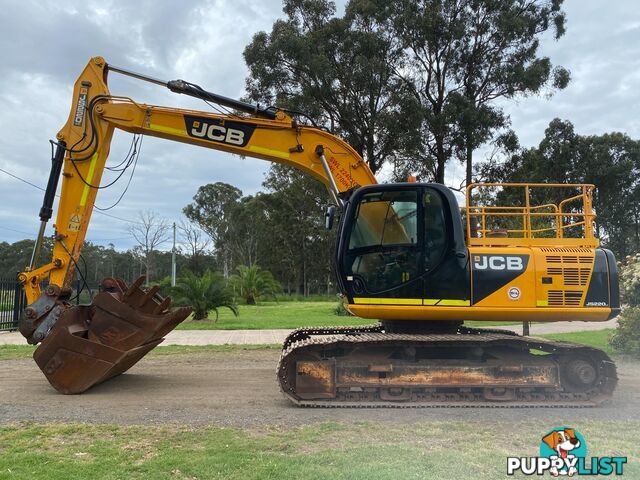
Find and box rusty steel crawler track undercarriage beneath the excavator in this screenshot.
[277,324,617,407]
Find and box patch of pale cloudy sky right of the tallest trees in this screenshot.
[503,0,640,146]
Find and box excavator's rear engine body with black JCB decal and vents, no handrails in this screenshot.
[348,247,619,322]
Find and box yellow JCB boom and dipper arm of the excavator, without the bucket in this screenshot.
[19,57,376,304]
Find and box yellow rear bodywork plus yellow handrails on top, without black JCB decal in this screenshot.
[348,184,612,322]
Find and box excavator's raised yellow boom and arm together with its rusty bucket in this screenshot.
[19,57,376,393]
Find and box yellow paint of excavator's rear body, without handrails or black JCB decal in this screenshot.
[348,247,611,322]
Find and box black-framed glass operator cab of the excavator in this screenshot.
[338,183,470,305]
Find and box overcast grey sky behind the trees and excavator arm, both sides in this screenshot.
[0,0,640,248]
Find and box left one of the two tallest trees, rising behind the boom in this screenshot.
[244,0,404,173]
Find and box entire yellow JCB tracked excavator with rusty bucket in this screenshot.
[19,57,620,407]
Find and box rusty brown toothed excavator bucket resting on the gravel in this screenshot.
[33,277,191,394]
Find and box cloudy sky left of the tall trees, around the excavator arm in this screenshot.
[0,0,281,248]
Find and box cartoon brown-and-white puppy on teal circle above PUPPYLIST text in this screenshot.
[540,428,587,477]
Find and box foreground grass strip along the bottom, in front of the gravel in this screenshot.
[0,420,640,480]
